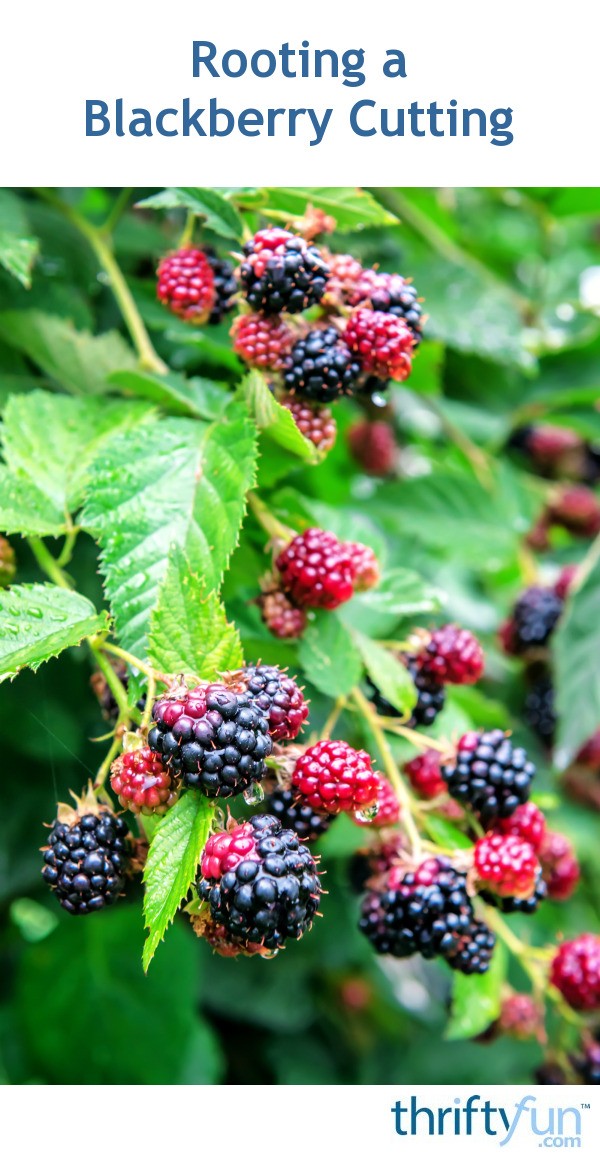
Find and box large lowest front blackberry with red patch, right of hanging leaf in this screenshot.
[196,815,321,950]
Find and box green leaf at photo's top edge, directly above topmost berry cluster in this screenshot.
[268,186,397,233]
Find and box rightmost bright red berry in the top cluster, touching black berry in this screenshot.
[344,308,415,382]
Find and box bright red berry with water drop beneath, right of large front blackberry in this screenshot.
[292,740,379,813]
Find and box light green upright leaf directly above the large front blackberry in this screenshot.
[148,548,243,680]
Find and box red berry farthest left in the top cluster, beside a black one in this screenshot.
[156,248,217,325]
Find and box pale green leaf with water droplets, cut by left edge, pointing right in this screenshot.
[0,584,108,682]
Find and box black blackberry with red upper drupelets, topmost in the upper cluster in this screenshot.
[240,228,329,314]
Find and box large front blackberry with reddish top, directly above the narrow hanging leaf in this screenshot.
[148,683,272,798]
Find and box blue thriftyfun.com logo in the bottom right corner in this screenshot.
[392,1093,587,1150]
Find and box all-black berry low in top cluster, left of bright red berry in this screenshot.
[284,325,360,402]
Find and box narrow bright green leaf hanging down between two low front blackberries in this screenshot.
[142,790,214,970]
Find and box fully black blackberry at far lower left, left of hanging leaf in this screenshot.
[42,797,130,916]
